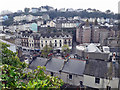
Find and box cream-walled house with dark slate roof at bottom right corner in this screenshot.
[83,60,119,90]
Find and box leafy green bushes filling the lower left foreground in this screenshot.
[0,43,63,89]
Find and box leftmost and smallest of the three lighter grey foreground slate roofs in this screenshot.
[30,57,47,69]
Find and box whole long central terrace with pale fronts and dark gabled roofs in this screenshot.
[21,33,72,50]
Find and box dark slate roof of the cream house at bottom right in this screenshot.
[84,60,118,78]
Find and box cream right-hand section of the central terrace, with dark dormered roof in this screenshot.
[40,34,72,49]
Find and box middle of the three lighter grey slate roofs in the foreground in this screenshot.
[46,58,64,72]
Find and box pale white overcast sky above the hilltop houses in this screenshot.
[0,0,120,13]
